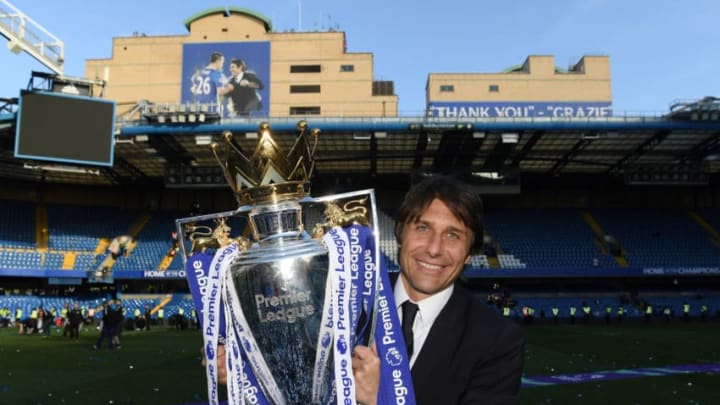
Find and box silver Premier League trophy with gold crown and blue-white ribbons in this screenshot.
[177,121,414,405]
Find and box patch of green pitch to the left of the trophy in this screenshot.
[0,327,207,405]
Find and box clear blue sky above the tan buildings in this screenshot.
[0,0,720,116]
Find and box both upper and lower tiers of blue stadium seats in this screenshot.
[0,201,720,327]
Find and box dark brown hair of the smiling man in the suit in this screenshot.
[395,176,485,255]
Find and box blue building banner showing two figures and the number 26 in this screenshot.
[181,41,270,118]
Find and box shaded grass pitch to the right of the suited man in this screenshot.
[521,320,720,405]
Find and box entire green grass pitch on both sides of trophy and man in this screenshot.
[0,321,720,405]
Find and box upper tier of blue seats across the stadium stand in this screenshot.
[0,201,720,271]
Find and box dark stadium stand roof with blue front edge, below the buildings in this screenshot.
[0,100,720,186]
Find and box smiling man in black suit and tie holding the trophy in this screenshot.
[353,177,523,405]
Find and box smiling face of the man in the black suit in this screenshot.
[400,199,473,301]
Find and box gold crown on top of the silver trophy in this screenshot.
[210,120,320,205]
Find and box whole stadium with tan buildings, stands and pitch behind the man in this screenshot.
[0,1,720,405]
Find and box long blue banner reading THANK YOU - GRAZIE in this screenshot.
[427,101,612,118]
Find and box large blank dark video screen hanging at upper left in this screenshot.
[15,92,115,166]
